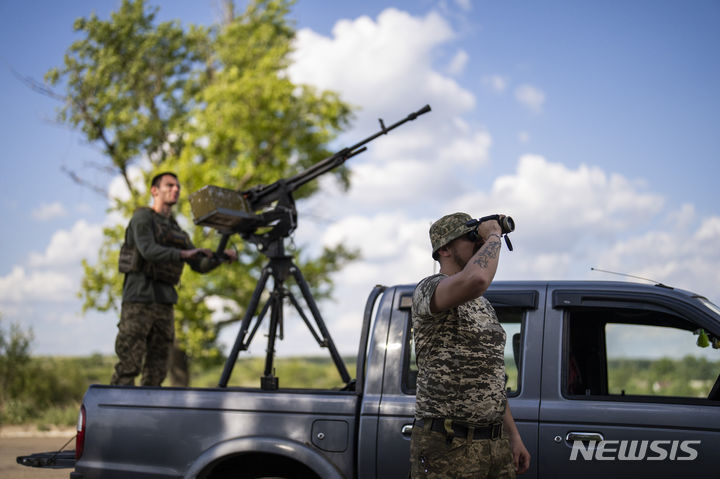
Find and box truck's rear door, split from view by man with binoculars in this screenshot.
[376,284,544,479]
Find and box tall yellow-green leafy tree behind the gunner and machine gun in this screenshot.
[46,0,356,384]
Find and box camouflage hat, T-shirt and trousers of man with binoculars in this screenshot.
[410,214,515,478]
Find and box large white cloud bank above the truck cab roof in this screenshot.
[422,155,720,299]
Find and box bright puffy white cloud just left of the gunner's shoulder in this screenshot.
[29,220,102,267]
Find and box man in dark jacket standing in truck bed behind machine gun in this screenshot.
[110,172,237,386]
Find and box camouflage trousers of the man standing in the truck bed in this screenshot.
[110,303,175,386]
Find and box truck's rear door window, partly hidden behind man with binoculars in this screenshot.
[402,307,525,396]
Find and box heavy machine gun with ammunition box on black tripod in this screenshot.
[190,105,430,390]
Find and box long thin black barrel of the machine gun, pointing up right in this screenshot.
[245,105,430,210]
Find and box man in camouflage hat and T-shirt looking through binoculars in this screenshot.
[410,213,530,479]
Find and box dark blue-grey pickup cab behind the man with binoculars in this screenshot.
[372,281,720,479]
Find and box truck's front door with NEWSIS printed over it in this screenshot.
[538,287,720,479]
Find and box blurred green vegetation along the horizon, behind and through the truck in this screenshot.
[0,322,720,428]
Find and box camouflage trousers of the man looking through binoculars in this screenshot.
[410,421,515,479]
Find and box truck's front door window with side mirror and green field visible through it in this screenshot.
[563,309,720,402]
